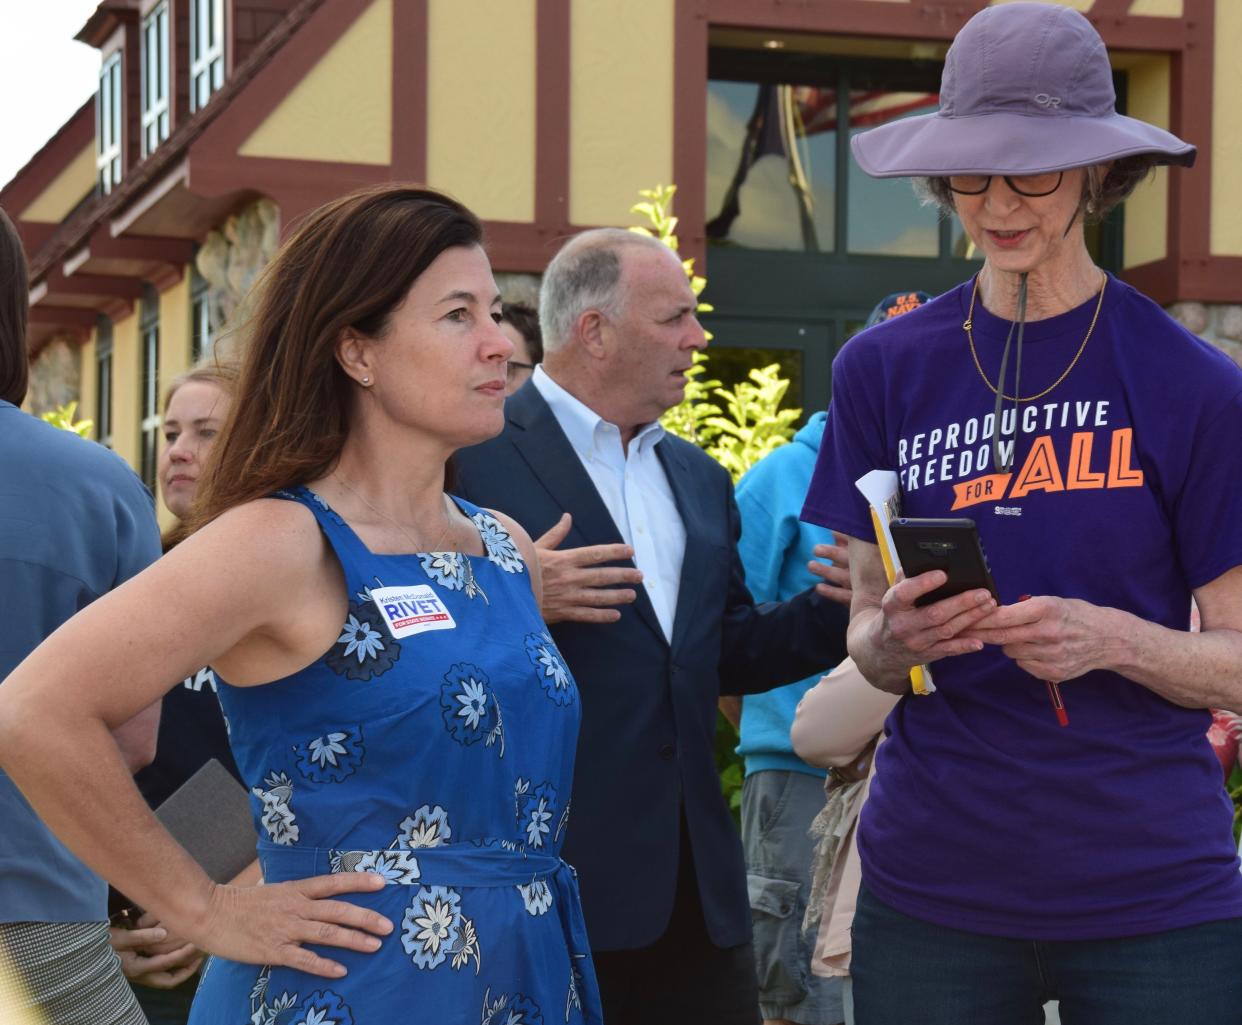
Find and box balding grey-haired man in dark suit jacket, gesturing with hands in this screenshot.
[457,229,847,1025]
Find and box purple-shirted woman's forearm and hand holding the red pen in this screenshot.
[969,567,1242,708]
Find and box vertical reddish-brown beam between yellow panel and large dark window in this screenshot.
[673,0,708,273]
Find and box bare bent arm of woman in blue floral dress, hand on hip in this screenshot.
[0,499,392,977]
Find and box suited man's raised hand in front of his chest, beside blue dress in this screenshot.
[535,513,642,624]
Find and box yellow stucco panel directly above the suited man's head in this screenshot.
[569,0,674,225]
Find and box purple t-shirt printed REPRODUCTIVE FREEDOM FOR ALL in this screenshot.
[802,278,1242,939]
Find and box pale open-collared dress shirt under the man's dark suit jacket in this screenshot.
[532,364,686,641]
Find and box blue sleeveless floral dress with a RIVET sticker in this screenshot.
[190,487,601,1025]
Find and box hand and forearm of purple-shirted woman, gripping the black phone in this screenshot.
[846,538,996,695]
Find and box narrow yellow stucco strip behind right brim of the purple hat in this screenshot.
[1113,55,1170,267]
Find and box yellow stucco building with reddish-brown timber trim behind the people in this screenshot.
[0,0,1242,511]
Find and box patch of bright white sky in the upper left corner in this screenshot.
[0,0,99,185]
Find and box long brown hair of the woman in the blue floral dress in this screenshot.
[186,183,483,533]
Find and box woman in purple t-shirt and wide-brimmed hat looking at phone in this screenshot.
[804,2,1242,1025]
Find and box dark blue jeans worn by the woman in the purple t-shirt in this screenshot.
[851,887,1242,1025]
